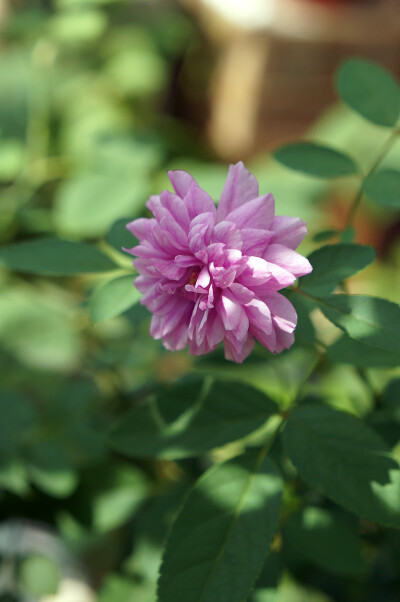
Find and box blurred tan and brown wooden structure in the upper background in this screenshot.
[181,0,400,160]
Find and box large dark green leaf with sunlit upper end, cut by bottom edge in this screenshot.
[158,451,282,602]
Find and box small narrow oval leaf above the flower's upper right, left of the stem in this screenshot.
[274,142,359,178]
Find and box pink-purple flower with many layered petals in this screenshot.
[127,162,312,362]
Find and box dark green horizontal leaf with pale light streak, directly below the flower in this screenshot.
[111,380,278,459]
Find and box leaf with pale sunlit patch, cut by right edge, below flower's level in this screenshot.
[315,295,400,353]
